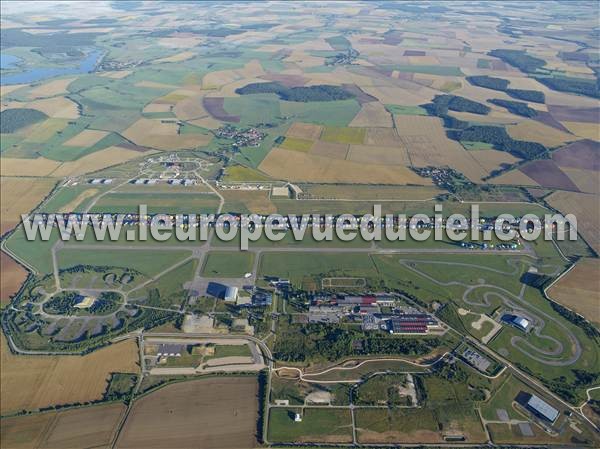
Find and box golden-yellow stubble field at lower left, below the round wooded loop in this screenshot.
[0,334,139,414]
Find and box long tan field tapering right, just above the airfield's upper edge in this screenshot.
[259,148,431,185]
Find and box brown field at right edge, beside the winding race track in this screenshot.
[548,259,600,324]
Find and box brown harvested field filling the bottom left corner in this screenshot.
[0,403,125,449]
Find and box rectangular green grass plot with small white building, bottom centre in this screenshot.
[268,408,352,443]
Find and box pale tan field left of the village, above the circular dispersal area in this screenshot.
[123,118,211,151]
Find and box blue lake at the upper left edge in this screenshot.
[0,50,103,85]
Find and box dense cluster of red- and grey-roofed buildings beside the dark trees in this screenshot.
[308,295,442,334]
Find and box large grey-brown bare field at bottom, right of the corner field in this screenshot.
[117,377,258,449]
